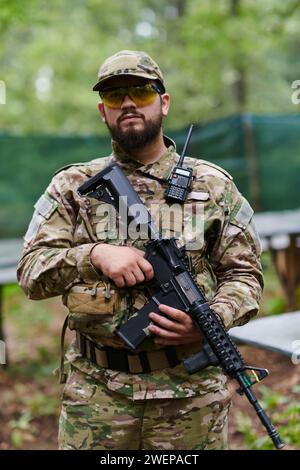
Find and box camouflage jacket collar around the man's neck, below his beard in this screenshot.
[112,135,179,180]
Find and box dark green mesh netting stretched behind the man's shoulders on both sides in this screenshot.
[0,115,300,238]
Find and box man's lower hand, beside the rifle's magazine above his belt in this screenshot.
[149,304,202,346]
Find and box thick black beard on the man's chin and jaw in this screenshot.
[107,114,162,154]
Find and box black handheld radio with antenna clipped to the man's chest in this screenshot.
[165,124,194,204]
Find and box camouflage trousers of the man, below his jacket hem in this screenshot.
[58,368,230,450]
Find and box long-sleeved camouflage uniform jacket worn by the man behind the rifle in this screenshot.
[18,137,263,406]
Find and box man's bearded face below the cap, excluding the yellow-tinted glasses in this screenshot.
[99,76,169,152]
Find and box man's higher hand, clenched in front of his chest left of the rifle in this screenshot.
[90,243,154,287]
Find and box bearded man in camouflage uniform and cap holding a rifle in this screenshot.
[18,51,263,450]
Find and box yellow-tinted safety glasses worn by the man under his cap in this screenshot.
[99,83,161,109]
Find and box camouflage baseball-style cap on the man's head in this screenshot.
[93,51,165,92]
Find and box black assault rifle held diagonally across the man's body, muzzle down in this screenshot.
[78,164,284,449]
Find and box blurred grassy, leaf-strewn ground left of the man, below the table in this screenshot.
[0,285,66,449]
